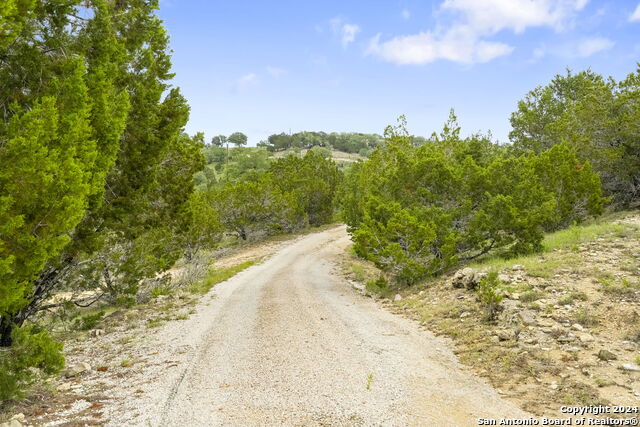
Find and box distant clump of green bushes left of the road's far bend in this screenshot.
[198,150,341,244]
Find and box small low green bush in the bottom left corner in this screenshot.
[0,326,64,401]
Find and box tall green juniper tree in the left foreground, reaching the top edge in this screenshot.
[0,0,205,398]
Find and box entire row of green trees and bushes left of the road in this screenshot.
[0,0,339,400]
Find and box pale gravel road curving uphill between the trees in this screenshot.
[108,227,527,426]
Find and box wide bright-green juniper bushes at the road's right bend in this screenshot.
[340,114,603,284]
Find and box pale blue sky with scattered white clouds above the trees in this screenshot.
[159,0,640,145]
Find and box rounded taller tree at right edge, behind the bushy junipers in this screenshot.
[510,70,640,205]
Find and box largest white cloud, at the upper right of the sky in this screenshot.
[367,0,588,64]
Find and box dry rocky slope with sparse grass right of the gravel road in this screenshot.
[346,214,640,417]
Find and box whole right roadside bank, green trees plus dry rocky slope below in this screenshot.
[341,67,640,422]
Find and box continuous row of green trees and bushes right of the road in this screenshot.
[341,66,640,284]
